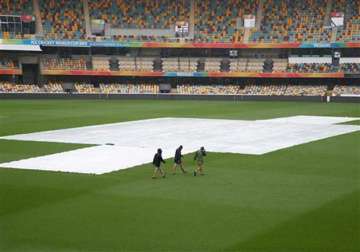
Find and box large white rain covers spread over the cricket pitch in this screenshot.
[0,116,360,174]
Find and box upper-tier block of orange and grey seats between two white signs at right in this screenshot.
[250,0,331,42]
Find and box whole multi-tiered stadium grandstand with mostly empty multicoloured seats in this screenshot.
[0,0,360,100]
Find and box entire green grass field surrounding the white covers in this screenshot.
[0,100,360,252]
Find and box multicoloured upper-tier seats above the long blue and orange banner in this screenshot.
[0,0,360,43]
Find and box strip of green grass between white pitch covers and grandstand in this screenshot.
[0,100,360,136]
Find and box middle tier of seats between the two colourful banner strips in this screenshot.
[40,56,360,73]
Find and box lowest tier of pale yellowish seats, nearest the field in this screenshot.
[0,82,360,96]
